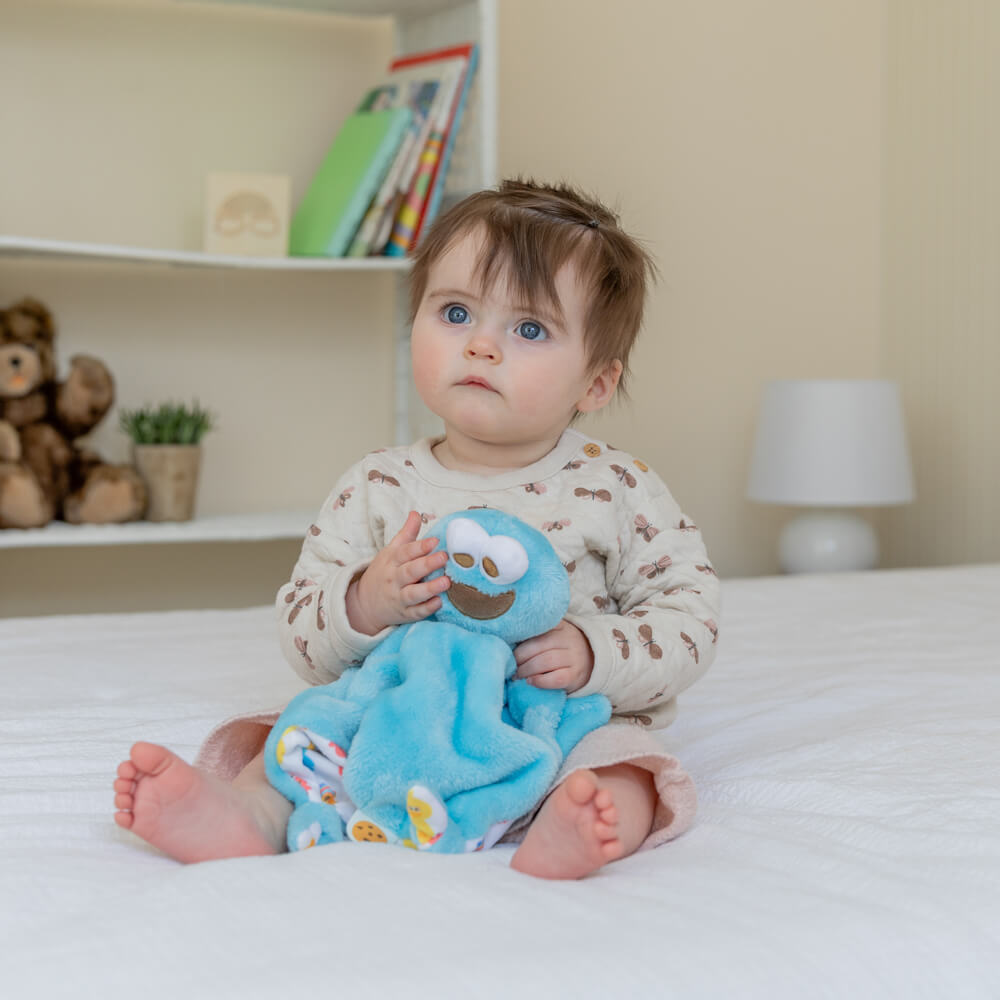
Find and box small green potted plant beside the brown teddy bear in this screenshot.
[119,402,215,521]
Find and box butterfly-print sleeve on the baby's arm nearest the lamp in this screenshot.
[569,473,719,713]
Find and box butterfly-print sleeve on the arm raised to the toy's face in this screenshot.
[275,463,392,684]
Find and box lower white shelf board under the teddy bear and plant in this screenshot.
[0,511,315,549]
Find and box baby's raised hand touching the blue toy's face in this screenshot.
[347,510,451,635]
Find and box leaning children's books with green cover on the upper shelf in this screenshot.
[288,44,478,257]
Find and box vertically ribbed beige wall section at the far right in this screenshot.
[885,0,1000,565]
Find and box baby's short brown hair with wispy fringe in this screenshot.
[410,179,656,393]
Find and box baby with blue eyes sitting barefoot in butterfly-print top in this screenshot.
[114,181,718,878]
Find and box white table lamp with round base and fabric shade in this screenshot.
[747,379,913,573]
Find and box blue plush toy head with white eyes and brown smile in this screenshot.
[428,509,569,645]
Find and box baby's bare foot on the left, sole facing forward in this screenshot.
[114,743,276,862]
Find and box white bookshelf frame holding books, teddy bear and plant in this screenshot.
[0,0,498,548]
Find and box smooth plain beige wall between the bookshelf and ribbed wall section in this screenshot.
[500,0,882,575]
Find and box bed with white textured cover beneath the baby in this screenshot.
[0,565,1000,1000]
